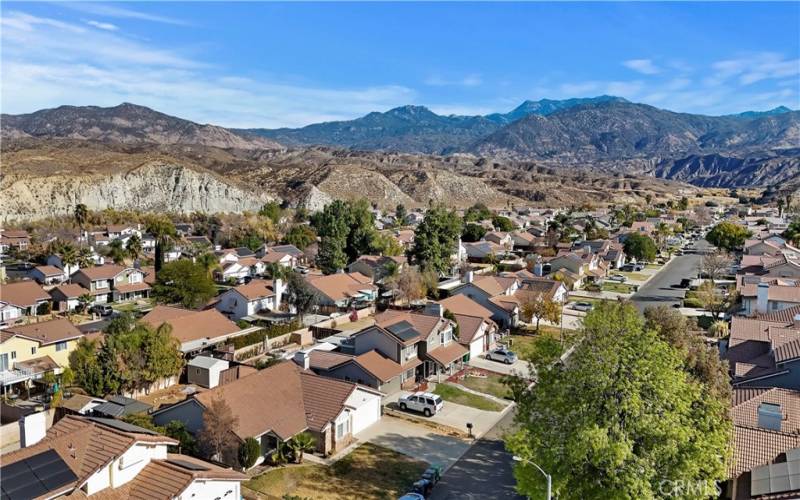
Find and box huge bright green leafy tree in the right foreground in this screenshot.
[506,303,732,499]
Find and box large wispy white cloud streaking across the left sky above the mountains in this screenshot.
[0,13,416,127]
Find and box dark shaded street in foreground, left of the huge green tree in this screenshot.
[431,411,525,500]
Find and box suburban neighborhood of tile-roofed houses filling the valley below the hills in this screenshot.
[0,189,800,499]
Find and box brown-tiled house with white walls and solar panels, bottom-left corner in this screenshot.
[0,415,247,500]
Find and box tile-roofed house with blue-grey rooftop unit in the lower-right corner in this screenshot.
[720,387,800,500]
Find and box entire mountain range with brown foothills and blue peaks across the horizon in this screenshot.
[0,96,800,218]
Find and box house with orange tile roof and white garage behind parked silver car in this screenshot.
[439,294,500,359]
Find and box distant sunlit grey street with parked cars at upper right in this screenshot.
[631,240,711,311]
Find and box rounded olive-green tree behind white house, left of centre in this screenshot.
[153,259,217,309]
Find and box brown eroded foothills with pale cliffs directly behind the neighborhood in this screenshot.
[0,138,694,220]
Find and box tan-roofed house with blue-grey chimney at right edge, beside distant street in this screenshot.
[736,275,800,316]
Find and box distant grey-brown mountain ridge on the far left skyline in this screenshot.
[0,103,281,149]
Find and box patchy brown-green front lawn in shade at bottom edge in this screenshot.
[243,443,428,500]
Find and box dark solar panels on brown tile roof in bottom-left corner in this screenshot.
[0,450,78,500]
